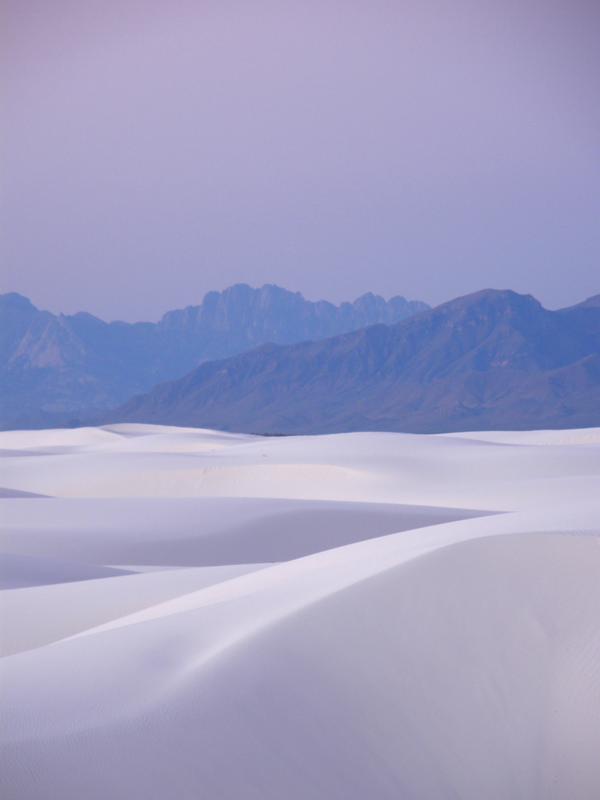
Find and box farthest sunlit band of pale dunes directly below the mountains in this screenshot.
[0,426,598,511]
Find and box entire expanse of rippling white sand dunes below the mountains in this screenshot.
[0,426,600,800]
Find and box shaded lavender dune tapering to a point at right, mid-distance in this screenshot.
[0,497,485,569]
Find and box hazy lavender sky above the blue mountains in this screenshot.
[1,0,600,319]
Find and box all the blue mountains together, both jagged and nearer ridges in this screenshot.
[0,284,600,434]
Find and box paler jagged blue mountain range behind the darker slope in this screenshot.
[0,284,428,429]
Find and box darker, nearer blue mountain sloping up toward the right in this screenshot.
[111,290,600,433]
